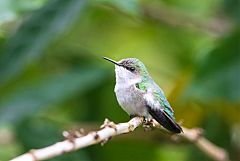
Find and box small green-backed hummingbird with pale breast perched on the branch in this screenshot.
[103,57,183,133]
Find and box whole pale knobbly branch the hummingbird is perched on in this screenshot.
[11,117,229,161]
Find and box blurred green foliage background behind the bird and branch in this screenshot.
[0,0,240,161]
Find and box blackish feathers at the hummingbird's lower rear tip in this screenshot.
[148,107,183,133]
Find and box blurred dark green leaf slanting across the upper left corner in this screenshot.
[0,0,85,84]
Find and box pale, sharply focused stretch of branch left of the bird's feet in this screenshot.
[11,117,143,161]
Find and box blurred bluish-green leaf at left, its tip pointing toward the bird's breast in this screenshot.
[0,67,106,123]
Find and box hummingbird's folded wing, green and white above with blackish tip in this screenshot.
[141,82,182,133]
